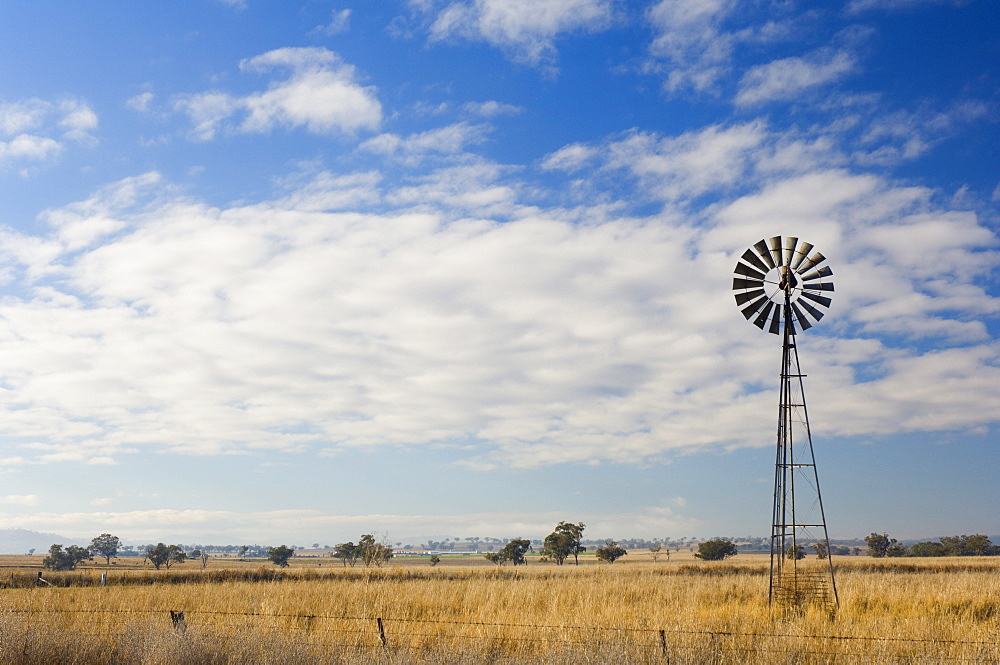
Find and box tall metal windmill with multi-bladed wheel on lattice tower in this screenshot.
[733,236,838,607]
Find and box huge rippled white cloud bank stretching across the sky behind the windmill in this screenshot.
[0,111,1000,468]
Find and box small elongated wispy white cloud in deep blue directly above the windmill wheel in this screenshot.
[735,49,856,106]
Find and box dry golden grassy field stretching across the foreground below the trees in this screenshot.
[0,554,1000,665]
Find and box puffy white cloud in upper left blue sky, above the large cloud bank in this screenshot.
[174,48,382,141]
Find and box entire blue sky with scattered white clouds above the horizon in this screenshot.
[0,0,1000,544]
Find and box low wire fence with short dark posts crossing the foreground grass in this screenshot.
[2,609,1000,665]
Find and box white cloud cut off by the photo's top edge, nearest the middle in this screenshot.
[431,0,611,65]
